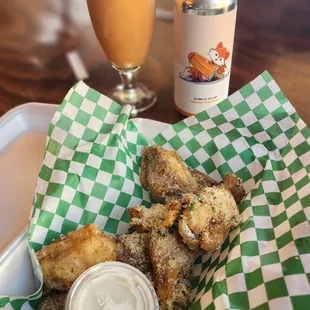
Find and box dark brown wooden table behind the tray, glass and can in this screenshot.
[0,0,310,125]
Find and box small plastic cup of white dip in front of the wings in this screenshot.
[65,262,159,310]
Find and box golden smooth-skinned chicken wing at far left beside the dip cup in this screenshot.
[36,224,118,291]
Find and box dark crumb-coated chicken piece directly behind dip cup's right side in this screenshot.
[117,232,153,281]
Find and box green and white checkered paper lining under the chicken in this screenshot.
[0,72,310,310]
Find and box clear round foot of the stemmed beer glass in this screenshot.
[111,83,157,117]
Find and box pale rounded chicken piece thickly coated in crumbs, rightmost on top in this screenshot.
[178,186,241,252]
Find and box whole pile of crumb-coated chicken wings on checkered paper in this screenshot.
[36,145,245,309]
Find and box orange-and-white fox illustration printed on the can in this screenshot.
[180,42,230,83]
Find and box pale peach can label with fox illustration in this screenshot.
[174,7,237,115]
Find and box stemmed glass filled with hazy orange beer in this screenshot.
[87,0,157,116]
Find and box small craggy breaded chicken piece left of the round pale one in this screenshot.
[128,200,182,232]
